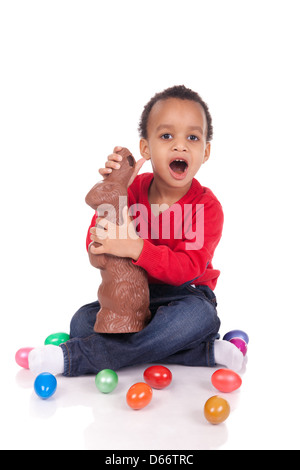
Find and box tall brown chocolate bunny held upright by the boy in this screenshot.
[85,148,151,333]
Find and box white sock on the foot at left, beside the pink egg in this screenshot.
[28,344,64,375]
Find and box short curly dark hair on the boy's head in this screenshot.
[138,85,213,142]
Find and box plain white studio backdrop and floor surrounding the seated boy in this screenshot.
[0,0,300,449]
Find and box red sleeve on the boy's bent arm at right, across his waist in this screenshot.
[133,201,224,286]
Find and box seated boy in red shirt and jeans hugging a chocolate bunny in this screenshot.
[29,86,243,376]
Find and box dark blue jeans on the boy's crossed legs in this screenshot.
[61,283,220,377]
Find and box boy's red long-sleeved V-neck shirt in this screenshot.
[86,173,224,290]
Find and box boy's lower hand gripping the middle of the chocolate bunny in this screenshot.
[90,207,144,261]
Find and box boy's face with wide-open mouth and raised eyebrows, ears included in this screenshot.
[140,98,210,188]
